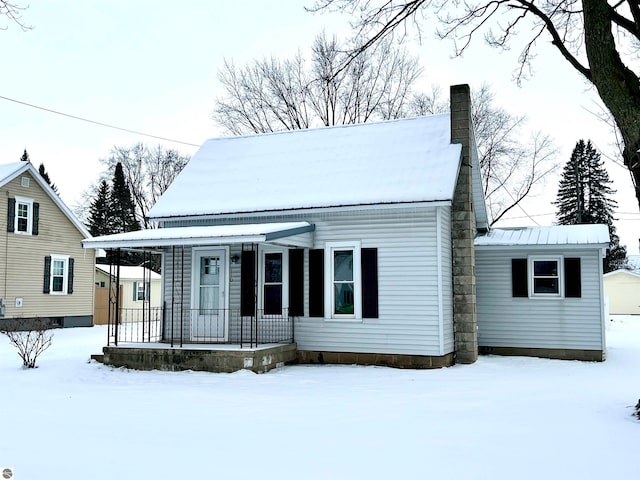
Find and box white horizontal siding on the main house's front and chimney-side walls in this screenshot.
[163,206,453,356]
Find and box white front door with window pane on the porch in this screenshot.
[191,249,229,342]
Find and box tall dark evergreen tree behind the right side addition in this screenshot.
[554,140,627,273]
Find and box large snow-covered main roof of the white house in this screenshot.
[149,114,461,219]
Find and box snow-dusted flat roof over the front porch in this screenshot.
[82,222,315,248]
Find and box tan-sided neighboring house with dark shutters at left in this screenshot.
[0,162,95,327]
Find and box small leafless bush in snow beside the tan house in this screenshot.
[0,318,53,368]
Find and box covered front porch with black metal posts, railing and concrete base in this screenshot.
[83,222,314,371]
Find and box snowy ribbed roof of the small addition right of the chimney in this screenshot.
[474,225,609,247]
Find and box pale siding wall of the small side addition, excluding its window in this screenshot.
[476,247,604,350]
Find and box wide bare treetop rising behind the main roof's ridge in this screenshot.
[212,34,421,135]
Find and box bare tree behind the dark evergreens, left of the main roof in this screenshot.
[96,143,189,228]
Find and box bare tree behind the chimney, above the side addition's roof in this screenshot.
[410,84,557,224]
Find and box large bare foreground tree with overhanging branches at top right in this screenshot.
[310,0,640,210]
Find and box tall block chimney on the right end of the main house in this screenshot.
[450,85,478,363]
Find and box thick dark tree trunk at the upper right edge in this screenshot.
[582,0,640,207]
